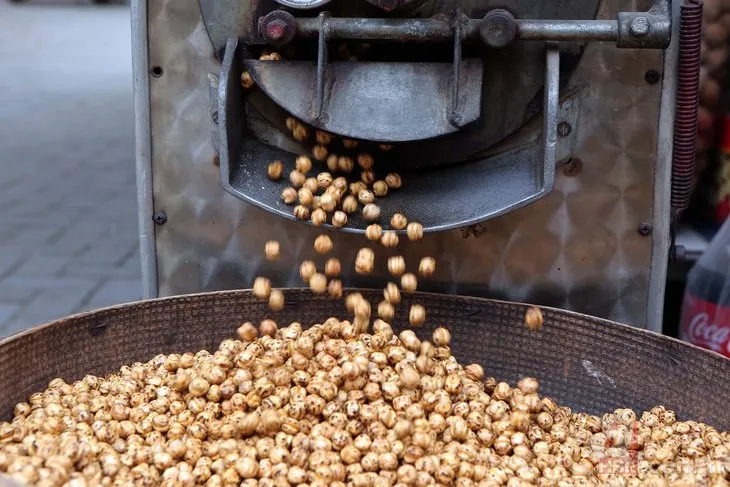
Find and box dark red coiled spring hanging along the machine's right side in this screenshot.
[671,0,703,211]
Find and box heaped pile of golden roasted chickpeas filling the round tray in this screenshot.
[0,314,730,487]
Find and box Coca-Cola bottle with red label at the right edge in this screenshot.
[680,219,730,357]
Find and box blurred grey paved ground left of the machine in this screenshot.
[0,0,141,336]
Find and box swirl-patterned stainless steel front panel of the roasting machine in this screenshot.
[141,0,668,327]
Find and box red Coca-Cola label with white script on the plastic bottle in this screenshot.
[680,292,730,357]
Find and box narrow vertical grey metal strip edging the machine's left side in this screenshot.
[131,0,157,298]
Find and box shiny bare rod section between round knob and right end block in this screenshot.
[515,19,618,42]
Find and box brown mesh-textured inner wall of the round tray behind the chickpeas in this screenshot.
[0,289,730,430]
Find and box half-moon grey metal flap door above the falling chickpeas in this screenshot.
[243,59,483,142]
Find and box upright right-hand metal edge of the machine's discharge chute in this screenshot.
[542,42,560,191]
